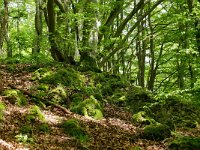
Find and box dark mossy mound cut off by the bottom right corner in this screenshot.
[169,137,200,150]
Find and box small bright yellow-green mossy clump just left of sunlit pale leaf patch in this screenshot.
[27,105,46,122]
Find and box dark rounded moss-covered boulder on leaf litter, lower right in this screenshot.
[142,123,171,141]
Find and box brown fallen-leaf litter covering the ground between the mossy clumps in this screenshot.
[0,65,200,150]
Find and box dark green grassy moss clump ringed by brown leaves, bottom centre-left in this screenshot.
[61,119,90,143]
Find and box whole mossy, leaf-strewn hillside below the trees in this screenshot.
[0,64,200,150]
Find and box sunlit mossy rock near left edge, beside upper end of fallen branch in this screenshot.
[2,89,27,106]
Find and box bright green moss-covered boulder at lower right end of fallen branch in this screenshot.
[71,96,103,119]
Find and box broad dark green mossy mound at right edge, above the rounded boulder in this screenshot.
[149,96,200,129]
